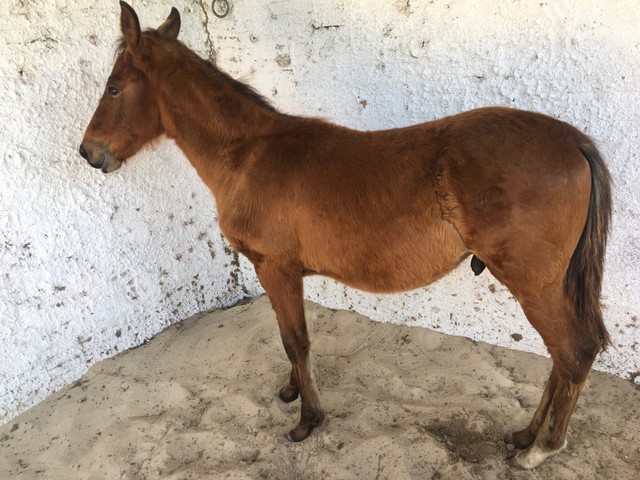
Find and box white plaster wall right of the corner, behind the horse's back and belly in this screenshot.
[221,0,640,384]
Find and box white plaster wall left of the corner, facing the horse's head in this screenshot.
[0,0,242,423]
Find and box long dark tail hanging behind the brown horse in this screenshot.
[564,141,612,350]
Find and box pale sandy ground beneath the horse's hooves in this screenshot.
[0,297,640,480]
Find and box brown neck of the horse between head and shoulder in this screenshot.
[154,58,285,189]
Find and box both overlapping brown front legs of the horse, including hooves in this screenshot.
[256,262,324,442]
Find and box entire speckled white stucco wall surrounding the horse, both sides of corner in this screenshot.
[0,0,640,422]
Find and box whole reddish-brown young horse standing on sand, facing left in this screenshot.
[80,2,611,468]
